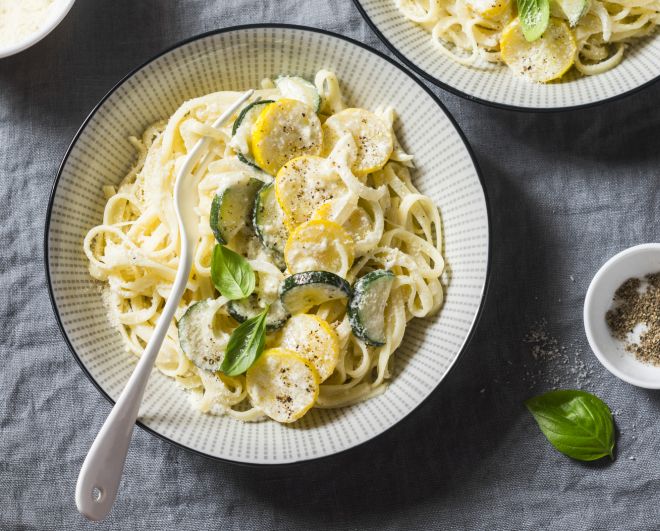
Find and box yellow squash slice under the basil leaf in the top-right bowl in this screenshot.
[500,18,577,83]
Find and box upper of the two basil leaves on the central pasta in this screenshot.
[211,245,255,300]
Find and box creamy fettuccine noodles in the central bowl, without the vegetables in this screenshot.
[84,71,444,421]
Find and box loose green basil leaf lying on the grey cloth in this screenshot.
[525,390,614,461]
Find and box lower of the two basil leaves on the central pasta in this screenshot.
[220,306,268,376]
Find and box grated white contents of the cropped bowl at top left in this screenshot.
[0,0,64,47]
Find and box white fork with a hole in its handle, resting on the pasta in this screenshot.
[76,90,254,520]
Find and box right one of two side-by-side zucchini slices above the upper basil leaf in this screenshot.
[252,183,289,262]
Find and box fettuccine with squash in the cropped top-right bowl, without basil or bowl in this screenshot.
[392,0,660,82]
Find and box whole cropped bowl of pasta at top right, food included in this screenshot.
[354,0,660,110]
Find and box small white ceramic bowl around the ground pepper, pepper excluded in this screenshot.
[584,243,660,389]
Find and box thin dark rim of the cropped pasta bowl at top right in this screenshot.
[353,0,660,113]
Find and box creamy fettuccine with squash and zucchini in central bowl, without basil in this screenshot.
[83,71,444,422]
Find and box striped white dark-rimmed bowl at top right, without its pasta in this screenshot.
[354,0,660,111]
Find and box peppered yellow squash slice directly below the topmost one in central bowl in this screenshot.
[275,155,346,230]
